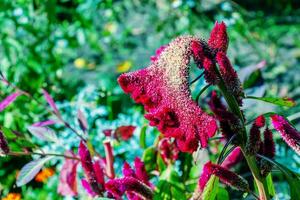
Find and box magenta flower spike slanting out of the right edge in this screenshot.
[271,115,300,155]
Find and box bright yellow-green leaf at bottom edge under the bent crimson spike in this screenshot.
[202,175,219,200]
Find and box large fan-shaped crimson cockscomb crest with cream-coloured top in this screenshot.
[118,36,217,152]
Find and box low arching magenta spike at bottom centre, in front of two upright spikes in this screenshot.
[105,177,153,199]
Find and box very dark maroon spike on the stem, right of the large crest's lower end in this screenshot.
[208,91,240,140]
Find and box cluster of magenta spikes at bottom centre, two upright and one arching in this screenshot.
[105,158,153,200]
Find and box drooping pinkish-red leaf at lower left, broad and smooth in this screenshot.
[57,151,79,196]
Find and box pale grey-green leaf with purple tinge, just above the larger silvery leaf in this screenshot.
[27,126,58,142]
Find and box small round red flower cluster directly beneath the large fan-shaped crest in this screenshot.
[158,138,179,164]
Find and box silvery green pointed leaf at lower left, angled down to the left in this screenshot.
[17,156,53,187]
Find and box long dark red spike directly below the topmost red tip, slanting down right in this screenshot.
[216,52,244,105]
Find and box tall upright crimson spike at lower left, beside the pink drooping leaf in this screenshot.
[78,141,104,195]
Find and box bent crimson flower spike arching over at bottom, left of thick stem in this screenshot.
[199,162,249,191]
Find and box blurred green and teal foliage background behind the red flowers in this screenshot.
[0,0,300,199]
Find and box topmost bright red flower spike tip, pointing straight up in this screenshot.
[208,22,229,53]
